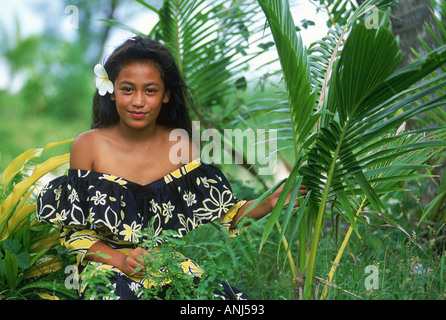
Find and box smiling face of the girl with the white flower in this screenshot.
[110,60,170,129]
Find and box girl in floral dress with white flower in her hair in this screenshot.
[37,37,304,299]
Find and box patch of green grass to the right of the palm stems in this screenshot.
[306,221,446,300]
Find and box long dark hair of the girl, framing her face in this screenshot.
[92,36,193,135]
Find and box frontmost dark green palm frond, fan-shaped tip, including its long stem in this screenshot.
[307,25,446,293]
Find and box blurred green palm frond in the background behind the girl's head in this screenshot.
[152,0,259,115]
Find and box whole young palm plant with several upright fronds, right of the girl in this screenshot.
[259,0,446,299]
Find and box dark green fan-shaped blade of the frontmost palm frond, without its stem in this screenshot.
[302,25,446,212]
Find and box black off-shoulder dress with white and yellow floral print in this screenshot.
[37,159,246,299]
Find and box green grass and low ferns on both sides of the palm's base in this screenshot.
[169,210,446,300]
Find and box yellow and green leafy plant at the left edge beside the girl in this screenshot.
[0,140,76,297]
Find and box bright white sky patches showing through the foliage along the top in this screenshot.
[0,0,327,88]
